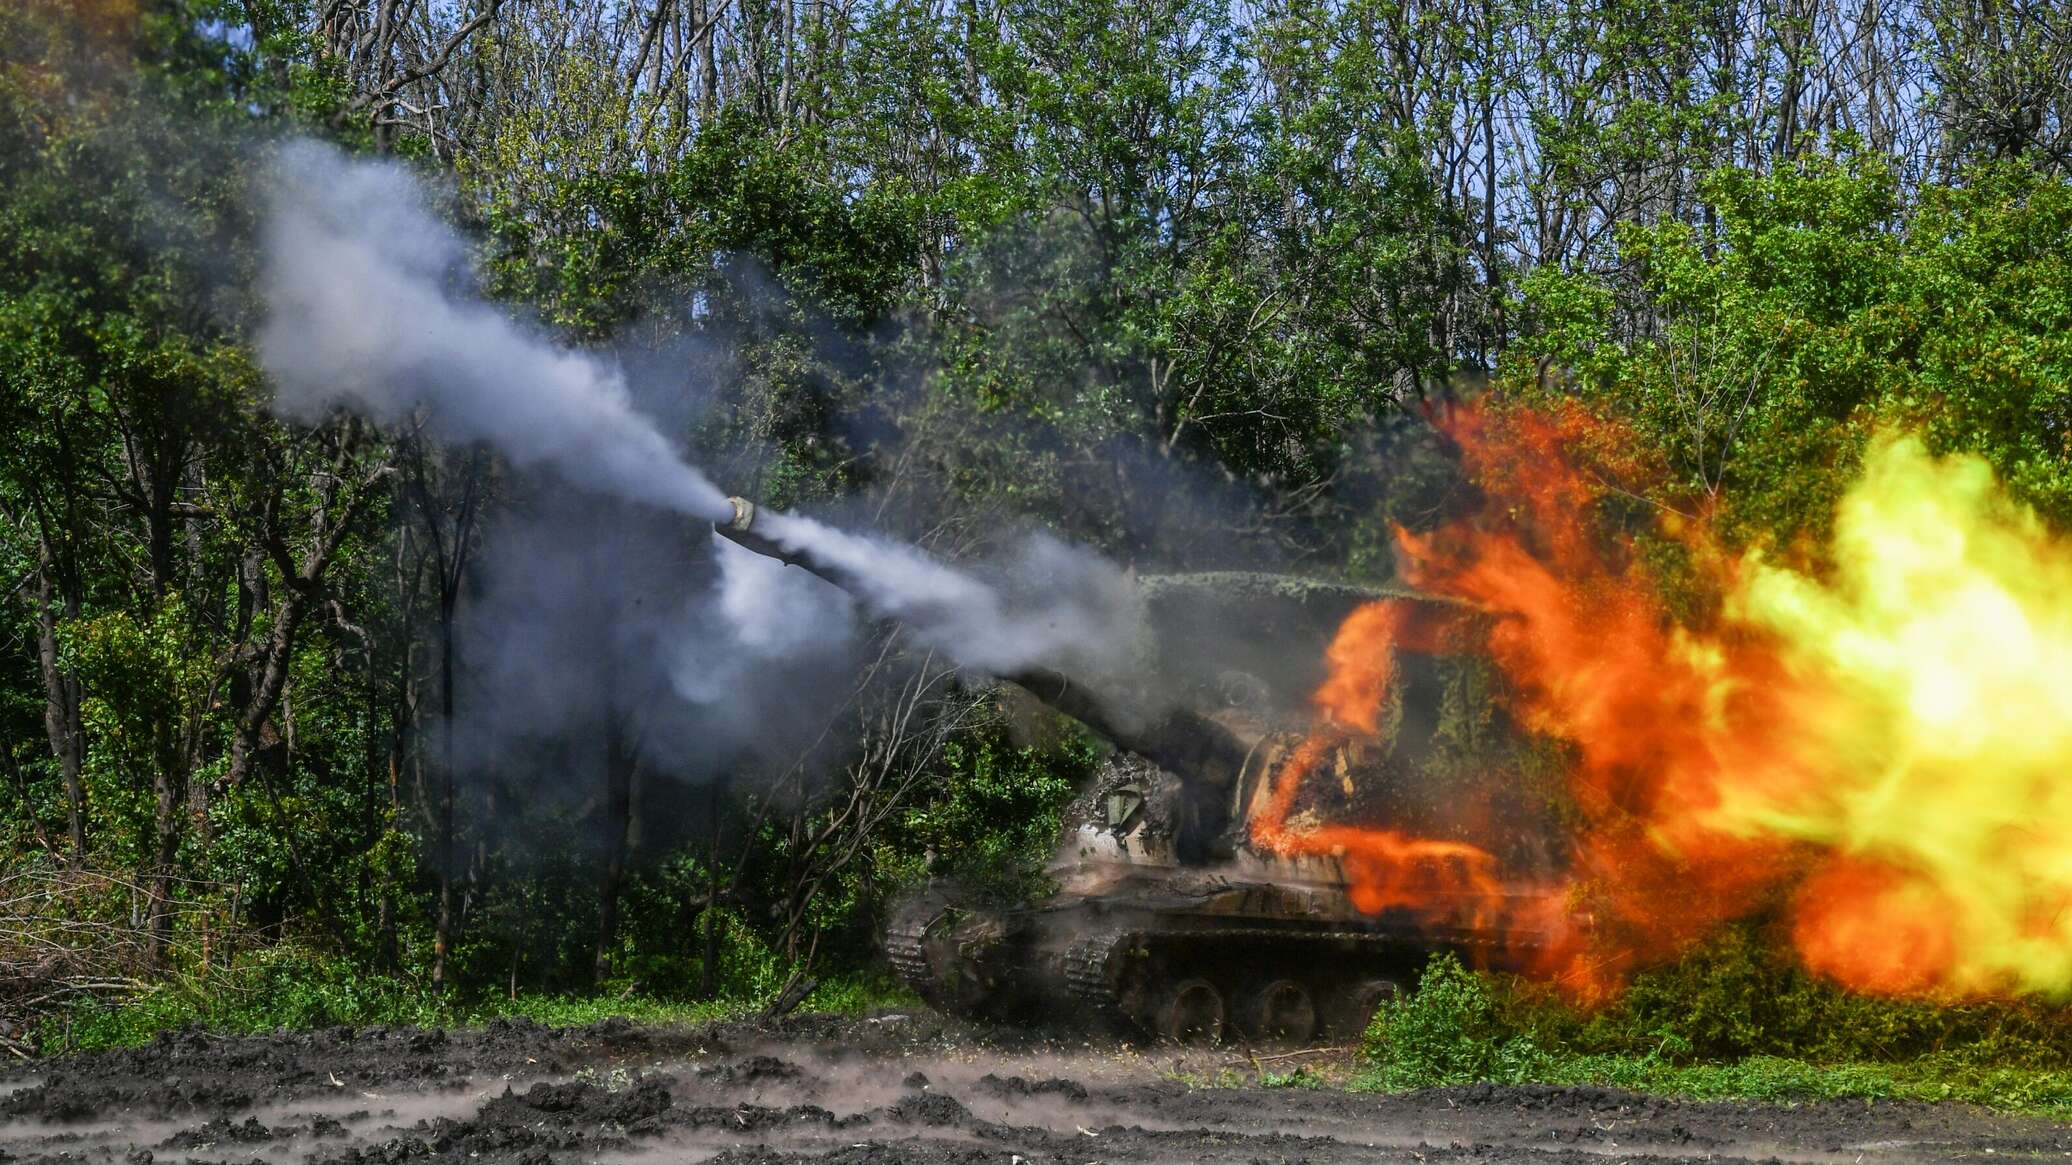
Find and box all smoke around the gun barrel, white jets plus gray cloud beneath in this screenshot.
[259,143,1140,733]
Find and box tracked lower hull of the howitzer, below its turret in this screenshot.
[885,754,1558,1043]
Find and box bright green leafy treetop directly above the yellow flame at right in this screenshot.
[1508,153,2072,543]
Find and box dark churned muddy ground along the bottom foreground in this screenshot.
[0,1014,2072,1165]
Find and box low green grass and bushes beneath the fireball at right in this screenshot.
[1355,925,2072,1115]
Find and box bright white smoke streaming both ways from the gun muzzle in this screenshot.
[259,141,1138,692]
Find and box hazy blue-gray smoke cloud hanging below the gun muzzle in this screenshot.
[454,489,858,788]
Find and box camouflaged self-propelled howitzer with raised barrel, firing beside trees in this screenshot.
[715,498,1546,1043]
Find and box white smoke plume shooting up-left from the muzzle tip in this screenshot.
[259,141,727,518]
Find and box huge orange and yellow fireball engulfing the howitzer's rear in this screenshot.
[1251,404,2072,999]
